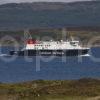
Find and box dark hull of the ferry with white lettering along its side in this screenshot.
[10,49,89,56]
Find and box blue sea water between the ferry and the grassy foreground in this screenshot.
[0,47,100,83]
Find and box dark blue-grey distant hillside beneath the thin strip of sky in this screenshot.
[0,1,100,30]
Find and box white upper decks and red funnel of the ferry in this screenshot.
[23,40,86,50]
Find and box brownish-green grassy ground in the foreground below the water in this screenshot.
[0,79,100,100]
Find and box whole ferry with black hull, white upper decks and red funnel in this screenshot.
[10,39,90,56]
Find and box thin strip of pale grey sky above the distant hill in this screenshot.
[0,0,90,4]
